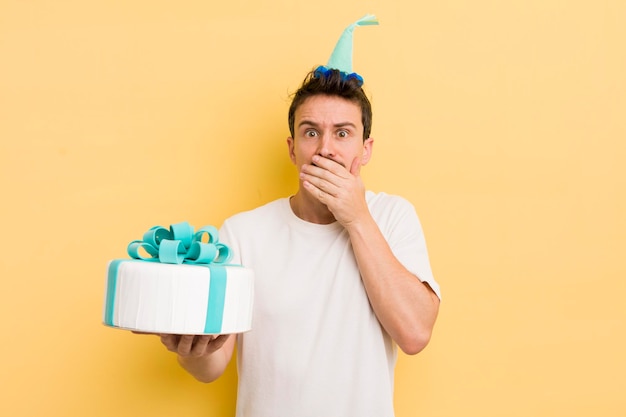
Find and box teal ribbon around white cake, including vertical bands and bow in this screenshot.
[105,222,232,334]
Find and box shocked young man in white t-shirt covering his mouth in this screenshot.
[161,67,439,417]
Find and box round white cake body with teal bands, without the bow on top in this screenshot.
[103,259,254,334]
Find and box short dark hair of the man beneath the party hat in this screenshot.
[288,69,372,141]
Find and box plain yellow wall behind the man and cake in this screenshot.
[0,0,626,417]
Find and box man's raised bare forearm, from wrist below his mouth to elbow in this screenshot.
[346,216,439,354]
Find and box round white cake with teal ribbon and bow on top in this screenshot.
[103,222,254,334]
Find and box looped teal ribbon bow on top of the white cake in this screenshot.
[127,222,232,264]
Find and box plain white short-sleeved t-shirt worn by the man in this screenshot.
[220,191,439,417]
